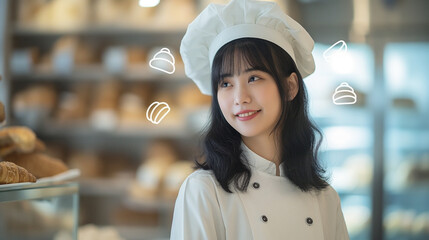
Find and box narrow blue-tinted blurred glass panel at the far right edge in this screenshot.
[383,43,429,240]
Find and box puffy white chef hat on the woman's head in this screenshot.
[180,0,315,95]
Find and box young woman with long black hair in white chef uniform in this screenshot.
[171,0,349,240]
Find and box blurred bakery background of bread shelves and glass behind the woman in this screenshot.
[0,0,429,240]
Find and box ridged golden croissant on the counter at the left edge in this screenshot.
[0,161,36,184]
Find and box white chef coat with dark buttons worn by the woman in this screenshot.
[170,143,349,240]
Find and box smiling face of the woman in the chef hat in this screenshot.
[217,60,281,137]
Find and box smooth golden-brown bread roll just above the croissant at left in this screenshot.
[0,127,36,156]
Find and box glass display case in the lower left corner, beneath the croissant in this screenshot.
[0,182,79,240]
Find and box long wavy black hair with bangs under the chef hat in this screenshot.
[195,38,328,193]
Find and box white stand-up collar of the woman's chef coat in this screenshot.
[241,141,285,177]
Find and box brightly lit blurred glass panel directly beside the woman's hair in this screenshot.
[305,41,374,240]
